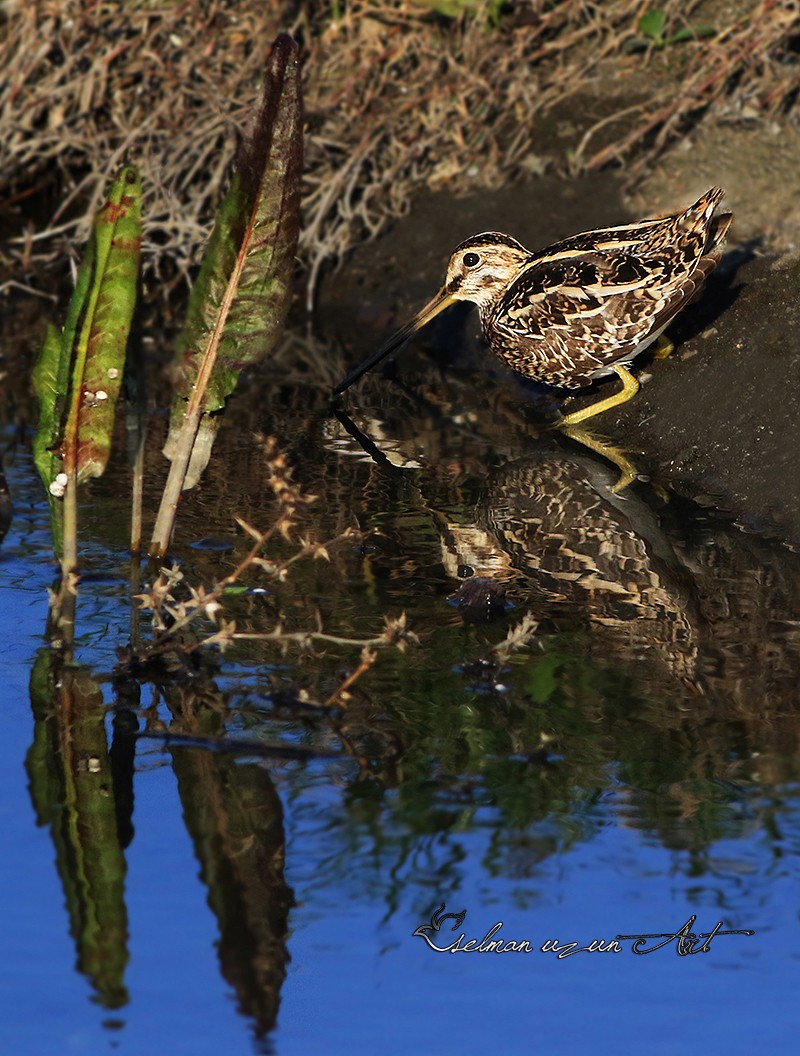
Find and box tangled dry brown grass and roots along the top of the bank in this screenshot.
[0,0,800,299]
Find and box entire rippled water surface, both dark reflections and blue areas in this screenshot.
[0,318,800,1054]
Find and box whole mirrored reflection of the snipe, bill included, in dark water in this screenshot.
[329,401,697,680]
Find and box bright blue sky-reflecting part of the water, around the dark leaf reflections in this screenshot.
[0,430,800,1056]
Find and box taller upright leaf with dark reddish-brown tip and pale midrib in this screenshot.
[165,34,303,487]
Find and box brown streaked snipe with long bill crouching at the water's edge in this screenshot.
[335,187,731,426]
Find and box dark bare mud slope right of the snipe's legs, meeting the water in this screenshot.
[603,250,800,546]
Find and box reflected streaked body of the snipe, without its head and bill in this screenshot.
[482,454,697,680]
